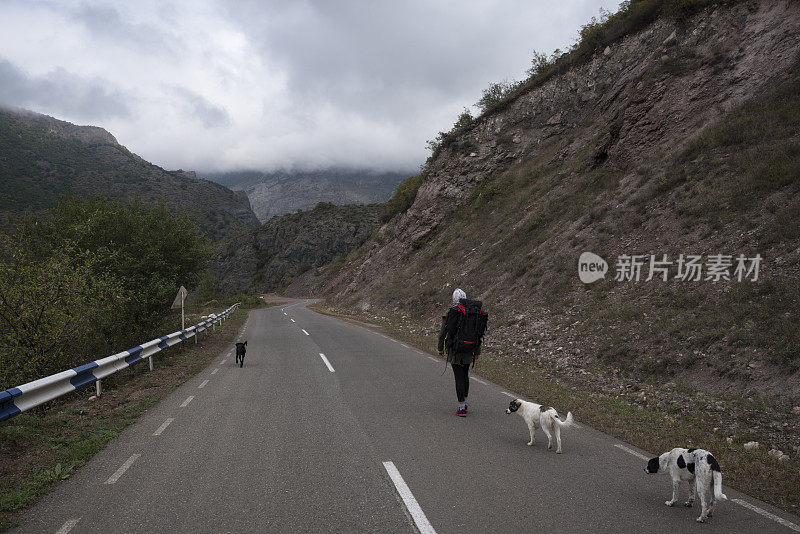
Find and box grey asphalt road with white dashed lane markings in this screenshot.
[14,302,800,534]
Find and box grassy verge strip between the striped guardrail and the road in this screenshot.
[0,303,250,531]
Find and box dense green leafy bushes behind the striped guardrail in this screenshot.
[0,198,209,389]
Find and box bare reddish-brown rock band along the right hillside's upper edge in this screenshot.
[327,1,800,303]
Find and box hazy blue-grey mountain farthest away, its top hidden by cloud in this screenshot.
[206,169,413,222]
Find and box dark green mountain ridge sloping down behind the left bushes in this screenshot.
[0,109,259,239]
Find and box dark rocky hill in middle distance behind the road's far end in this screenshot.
[209,202,380,293]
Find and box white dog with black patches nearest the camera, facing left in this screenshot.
[644,447,728,523]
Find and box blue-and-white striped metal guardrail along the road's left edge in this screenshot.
[0,302,239,421]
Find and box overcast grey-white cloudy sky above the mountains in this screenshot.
[0,0,619,171]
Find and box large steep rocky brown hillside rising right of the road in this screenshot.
[304,0,800,406]
